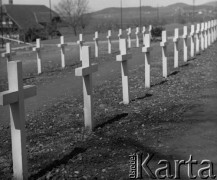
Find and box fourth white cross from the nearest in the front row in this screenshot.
[142,34,152,88]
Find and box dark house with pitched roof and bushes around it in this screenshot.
[1,0,60,41]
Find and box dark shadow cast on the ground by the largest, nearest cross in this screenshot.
[28,147,87,180]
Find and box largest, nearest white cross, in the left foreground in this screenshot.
[0,61,36,180]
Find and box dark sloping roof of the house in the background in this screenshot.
[4,5,59,29]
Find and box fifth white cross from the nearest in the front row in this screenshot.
[160,31,168,78]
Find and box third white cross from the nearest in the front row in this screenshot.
[116,39,132,104]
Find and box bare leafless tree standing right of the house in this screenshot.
[55,0,89,35]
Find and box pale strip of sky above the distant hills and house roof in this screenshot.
[8,0,214,11]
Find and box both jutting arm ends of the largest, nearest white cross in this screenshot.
[0,86,37,106]
